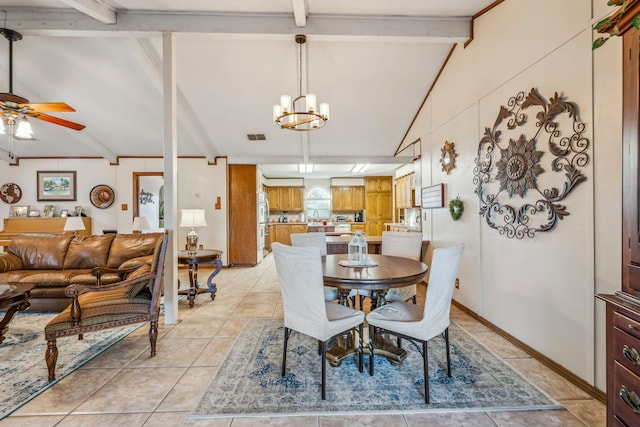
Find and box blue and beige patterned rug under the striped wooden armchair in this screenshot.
[0,311,142,419]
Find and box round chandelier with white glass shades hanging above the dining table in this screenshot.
[273,34,329,131]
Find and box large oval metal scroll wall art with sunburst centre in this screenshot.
[473,88,589,239]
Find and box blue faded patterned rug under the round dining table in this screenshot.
[189,319,562,419]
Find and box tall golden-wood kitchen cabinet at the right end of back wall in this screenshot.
[365,176,393,236]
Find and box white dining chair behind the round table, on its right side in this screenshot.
[359,231,422,309]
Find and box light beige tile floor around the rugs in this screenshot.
[0,255,606,427]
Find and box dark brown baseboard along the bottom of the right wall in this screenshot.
[453,300,607,403]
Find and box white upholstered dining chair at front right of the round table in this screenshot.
[367,245,464,403]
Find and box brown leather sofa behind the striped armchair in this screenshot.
[0,233,162,311]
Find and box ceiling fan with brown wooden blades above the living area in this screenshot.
[0,28,85,130]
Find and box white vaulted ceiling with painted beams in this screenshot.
[0,0,493,177]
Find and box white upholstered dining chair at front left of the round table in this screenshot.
[271,242,364,400]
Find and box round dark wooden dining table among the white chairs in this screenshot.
[322,254,428,366]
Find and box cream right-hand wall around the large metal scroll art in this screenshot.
[407,0,622,390]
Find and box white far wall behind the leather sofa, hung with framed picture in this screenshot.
[0,158,227,265]
